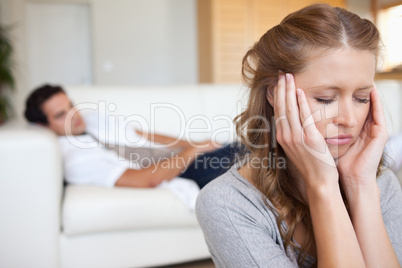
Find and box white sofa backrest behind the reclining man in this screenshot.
[66,85,247,143]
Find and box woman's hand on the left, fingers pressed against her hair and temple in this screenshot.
[274,74,339,189]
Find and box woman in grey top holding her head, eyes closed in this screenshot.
[196,5,402,268]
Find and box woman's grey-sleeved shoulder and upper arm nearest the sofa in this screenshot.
[196,166,302,267]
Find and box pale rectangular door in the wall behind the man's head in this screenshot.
[24,3,92,88]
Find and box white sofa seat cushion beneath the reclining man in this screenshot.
[62,185,198,235]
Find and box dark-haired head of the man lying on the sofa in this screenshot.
[25,85,85,136]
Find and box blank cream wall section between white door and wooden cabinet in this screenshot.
[92,0,198,85]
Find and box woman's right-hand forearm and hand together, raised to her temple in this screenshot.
[338,89,400,267]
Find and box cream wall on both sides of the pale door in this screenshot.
[0,0,198,119]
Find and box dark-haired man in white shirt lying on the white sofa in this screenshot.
[25,85,245,188]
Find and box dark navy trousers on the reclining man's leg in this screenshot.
[180,142,247,188]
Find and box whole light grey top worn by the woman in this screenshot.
[196,165,402,268]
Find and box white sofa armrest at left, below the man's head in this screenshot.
[0,122,63,267]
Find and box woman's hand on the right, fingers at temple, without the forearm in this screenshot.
[338,88,388,193]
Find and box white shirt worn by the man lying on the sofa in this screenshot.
[59,112,142,187]
